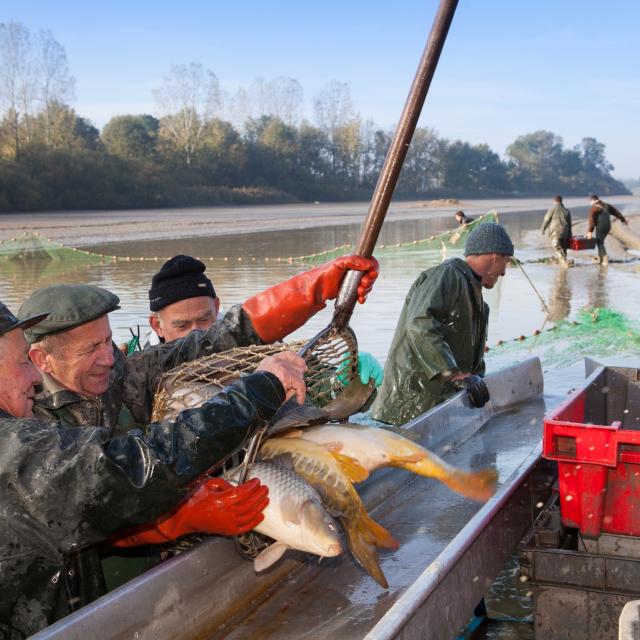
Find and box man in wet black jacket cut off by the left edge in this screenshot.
[0,304,304,640]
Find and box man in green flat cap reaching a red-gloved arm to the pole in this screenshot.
[19,256,378,434]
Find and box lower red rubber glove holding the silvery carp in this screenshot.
[112,478,269,547]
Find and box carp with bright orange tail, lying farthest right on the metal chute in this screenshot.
[298,424,498,502]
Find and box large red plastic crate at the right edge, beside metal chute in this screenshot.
[543,367,640,538]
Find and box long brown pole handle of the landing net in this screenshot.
[332,0,458,330]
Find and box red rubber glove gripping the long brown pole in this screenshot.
[242,256,380,342]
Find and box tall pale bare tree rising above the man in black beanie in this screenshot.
[153,62,220,164]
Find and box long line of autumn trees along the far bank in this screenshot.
[0,23,628,211]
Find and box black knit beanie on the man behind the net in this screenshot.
[149,256,216,311]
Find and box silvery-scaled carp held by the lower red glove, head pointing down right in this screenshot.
[230,462,342,572]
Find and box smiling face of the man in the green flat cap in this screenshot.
[31,316,115,398]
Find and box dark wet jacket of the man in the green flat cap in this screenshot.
[33,305,261,435]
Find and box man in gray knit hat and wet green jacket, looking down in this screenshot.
[372,222,513,425]
